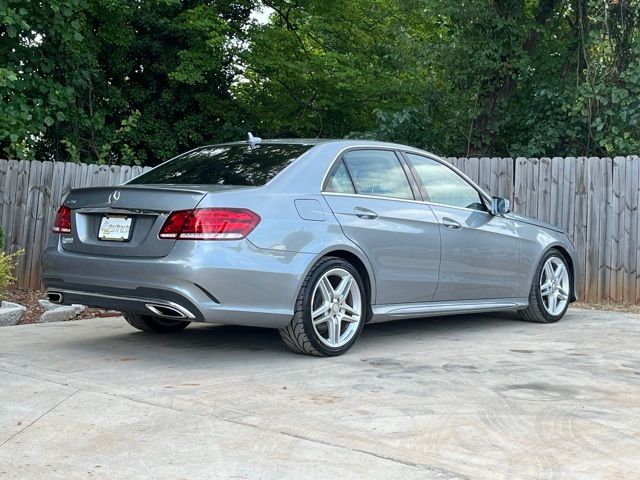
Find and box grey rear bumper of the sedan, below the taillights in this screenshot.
[42,235,314,328]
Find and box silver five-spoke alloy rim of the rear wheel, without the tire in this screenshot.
[311,268,362,348]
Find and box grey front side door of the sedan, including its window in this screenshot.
[405,153,520,301]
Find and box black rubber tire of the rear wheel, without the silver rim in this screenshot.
[279,257,370,357]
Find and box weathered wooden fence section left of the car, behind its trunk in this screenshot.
[0,160,148,288]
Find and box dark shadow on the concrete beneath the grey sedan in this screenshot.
[58,312,532,355]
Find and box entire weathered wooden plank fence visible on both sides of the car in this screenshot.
[0,156,640,304]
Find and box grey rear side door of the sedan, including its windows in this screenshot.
[323,149,440,305]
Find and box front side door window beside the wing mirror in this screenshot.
[407,154,485,210]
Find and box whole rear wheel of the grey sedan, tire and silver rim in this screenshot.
[280,257,368,357]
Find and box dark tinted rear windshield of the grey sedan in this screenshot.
[129,144,313,186]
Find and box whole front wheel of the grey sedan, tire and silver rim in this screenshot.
[519,249,572,323]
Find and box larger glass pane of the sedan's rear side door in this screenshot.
[344,150,413,199]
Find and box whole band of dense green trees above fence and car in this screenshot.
[0,0,640,161]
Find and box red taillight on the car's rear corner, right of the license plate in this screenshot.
[158,208,260,240]
